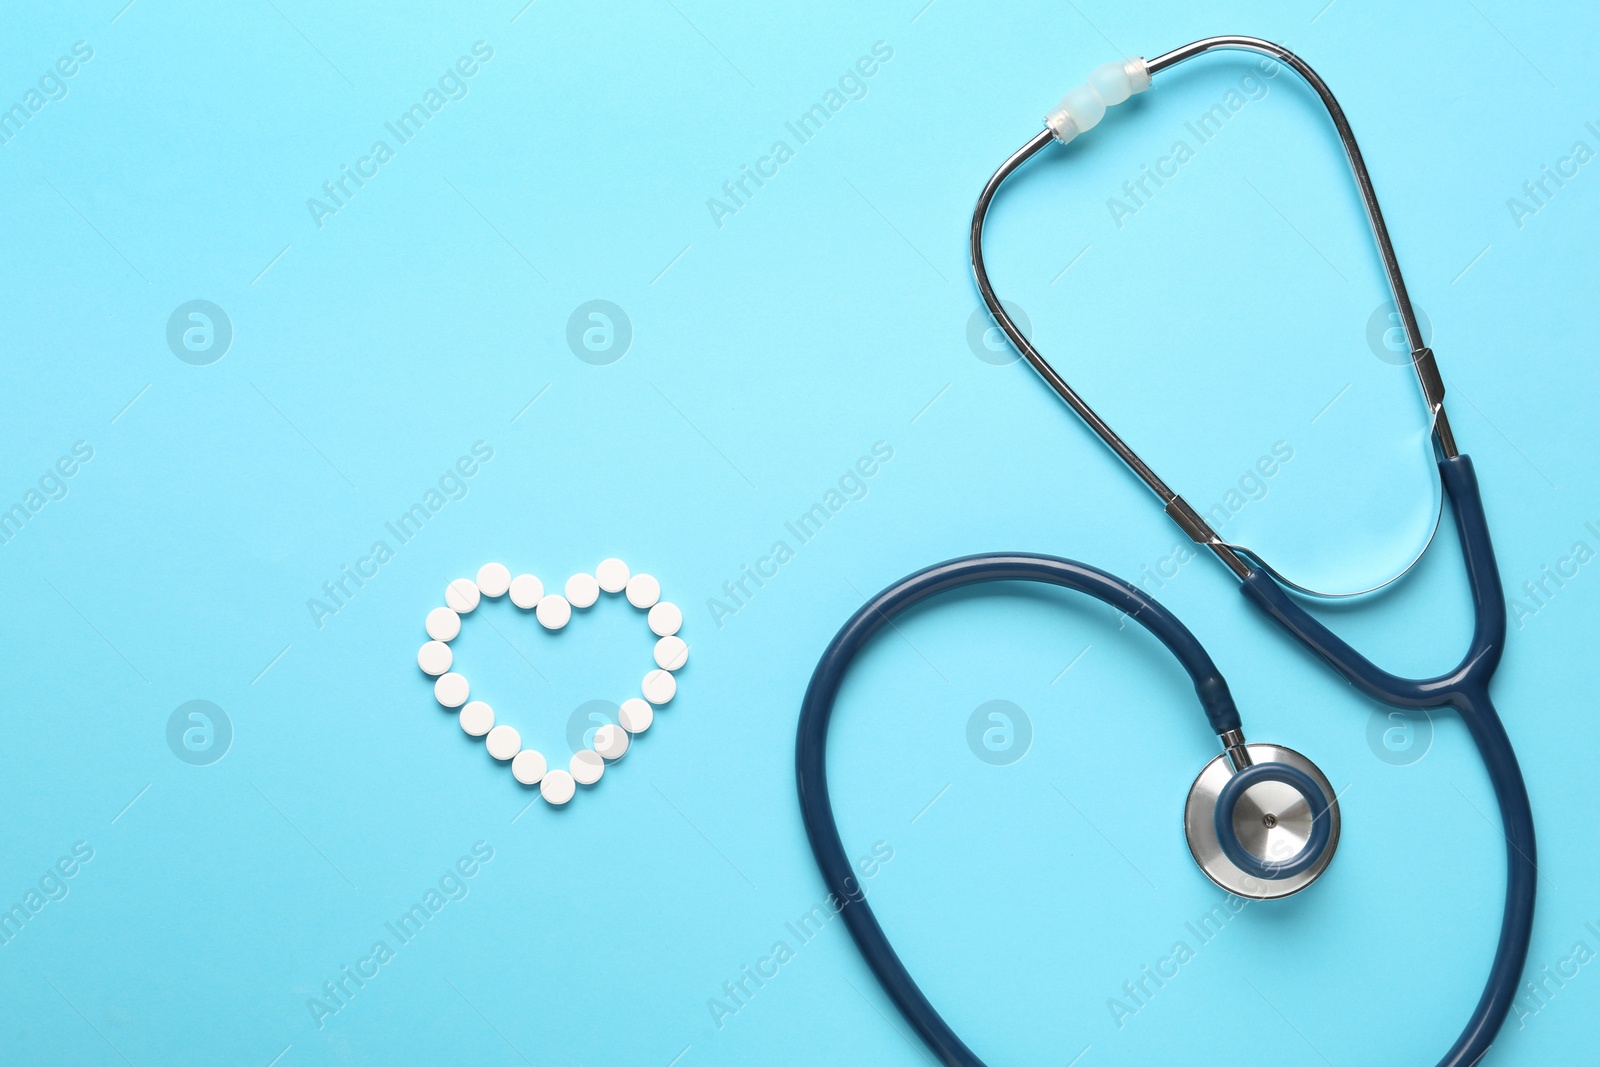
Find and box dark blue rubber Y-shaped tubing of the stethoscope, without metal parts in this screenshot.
[795,456,1538,1067]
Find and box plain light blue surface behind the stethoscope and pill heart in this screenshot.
[0,0,1600,1067]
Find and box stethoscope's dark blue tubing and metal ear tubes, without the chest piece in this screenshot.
[795,37,1538,1067]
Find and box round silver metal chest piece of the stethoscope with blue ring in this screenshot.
[1184,744,1339,901]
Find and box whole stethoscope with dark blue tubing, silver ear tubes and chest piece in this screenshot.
[795,37,1536,1067]
